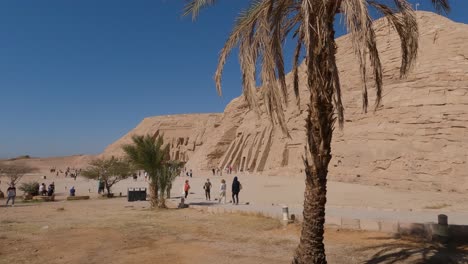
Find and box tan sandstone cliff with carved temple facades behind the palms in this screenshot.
[104,12,468,191]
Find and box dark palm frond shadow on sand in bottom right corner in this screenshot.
[360,238,468,264]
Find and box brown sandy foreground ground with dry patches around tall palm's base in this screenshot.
[0,198,468,264]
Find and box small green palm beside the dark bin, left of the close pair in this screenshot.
[122,135,169,208]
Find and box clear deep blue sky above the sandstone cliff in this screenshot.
[0,0,468,158]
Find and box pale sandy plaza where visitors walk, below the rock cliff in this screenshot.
[0,161,468,225]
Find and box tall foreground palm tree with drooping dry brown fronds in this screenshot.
[184,0,449,263]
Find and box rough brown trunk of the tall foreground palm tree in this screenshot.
[293,3,339,264]
